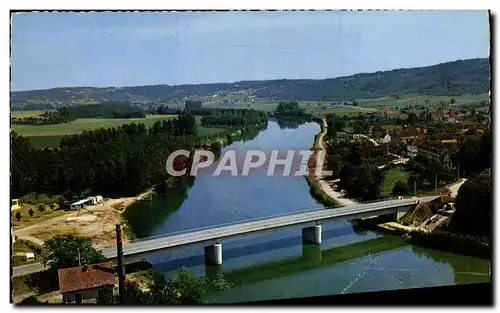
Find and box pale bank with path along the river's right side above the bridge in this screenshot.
[306,119,356,206]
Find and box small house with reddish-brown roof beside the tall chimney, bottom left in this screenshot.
[58,262,116,304]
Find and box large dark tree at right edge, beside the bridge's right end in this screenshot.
[450,171,493,238]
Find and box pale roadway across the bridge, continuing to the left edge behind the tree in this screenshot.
[13,196,436,276]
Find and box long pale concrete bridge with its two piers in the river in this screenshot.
[102,196,436,264]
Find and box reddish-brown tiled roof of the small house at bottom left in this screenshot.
[58,262,115,293]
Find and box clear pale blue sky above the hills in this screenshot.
[11,11,490,91]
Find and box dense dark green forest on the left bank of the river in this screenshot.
[11,115,196,199]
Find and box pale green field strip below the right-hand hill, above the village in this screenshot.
[357,93,489,110]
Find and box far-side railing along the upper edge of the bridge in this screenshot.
[133,197,418,242]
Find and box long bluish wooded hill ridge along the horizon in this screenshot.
[11,59,490,109]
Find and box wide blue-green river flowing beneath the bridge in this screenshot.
[126,120,490,303]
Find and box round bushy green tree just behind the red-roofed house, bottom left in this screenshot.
[42,235,105,270]
